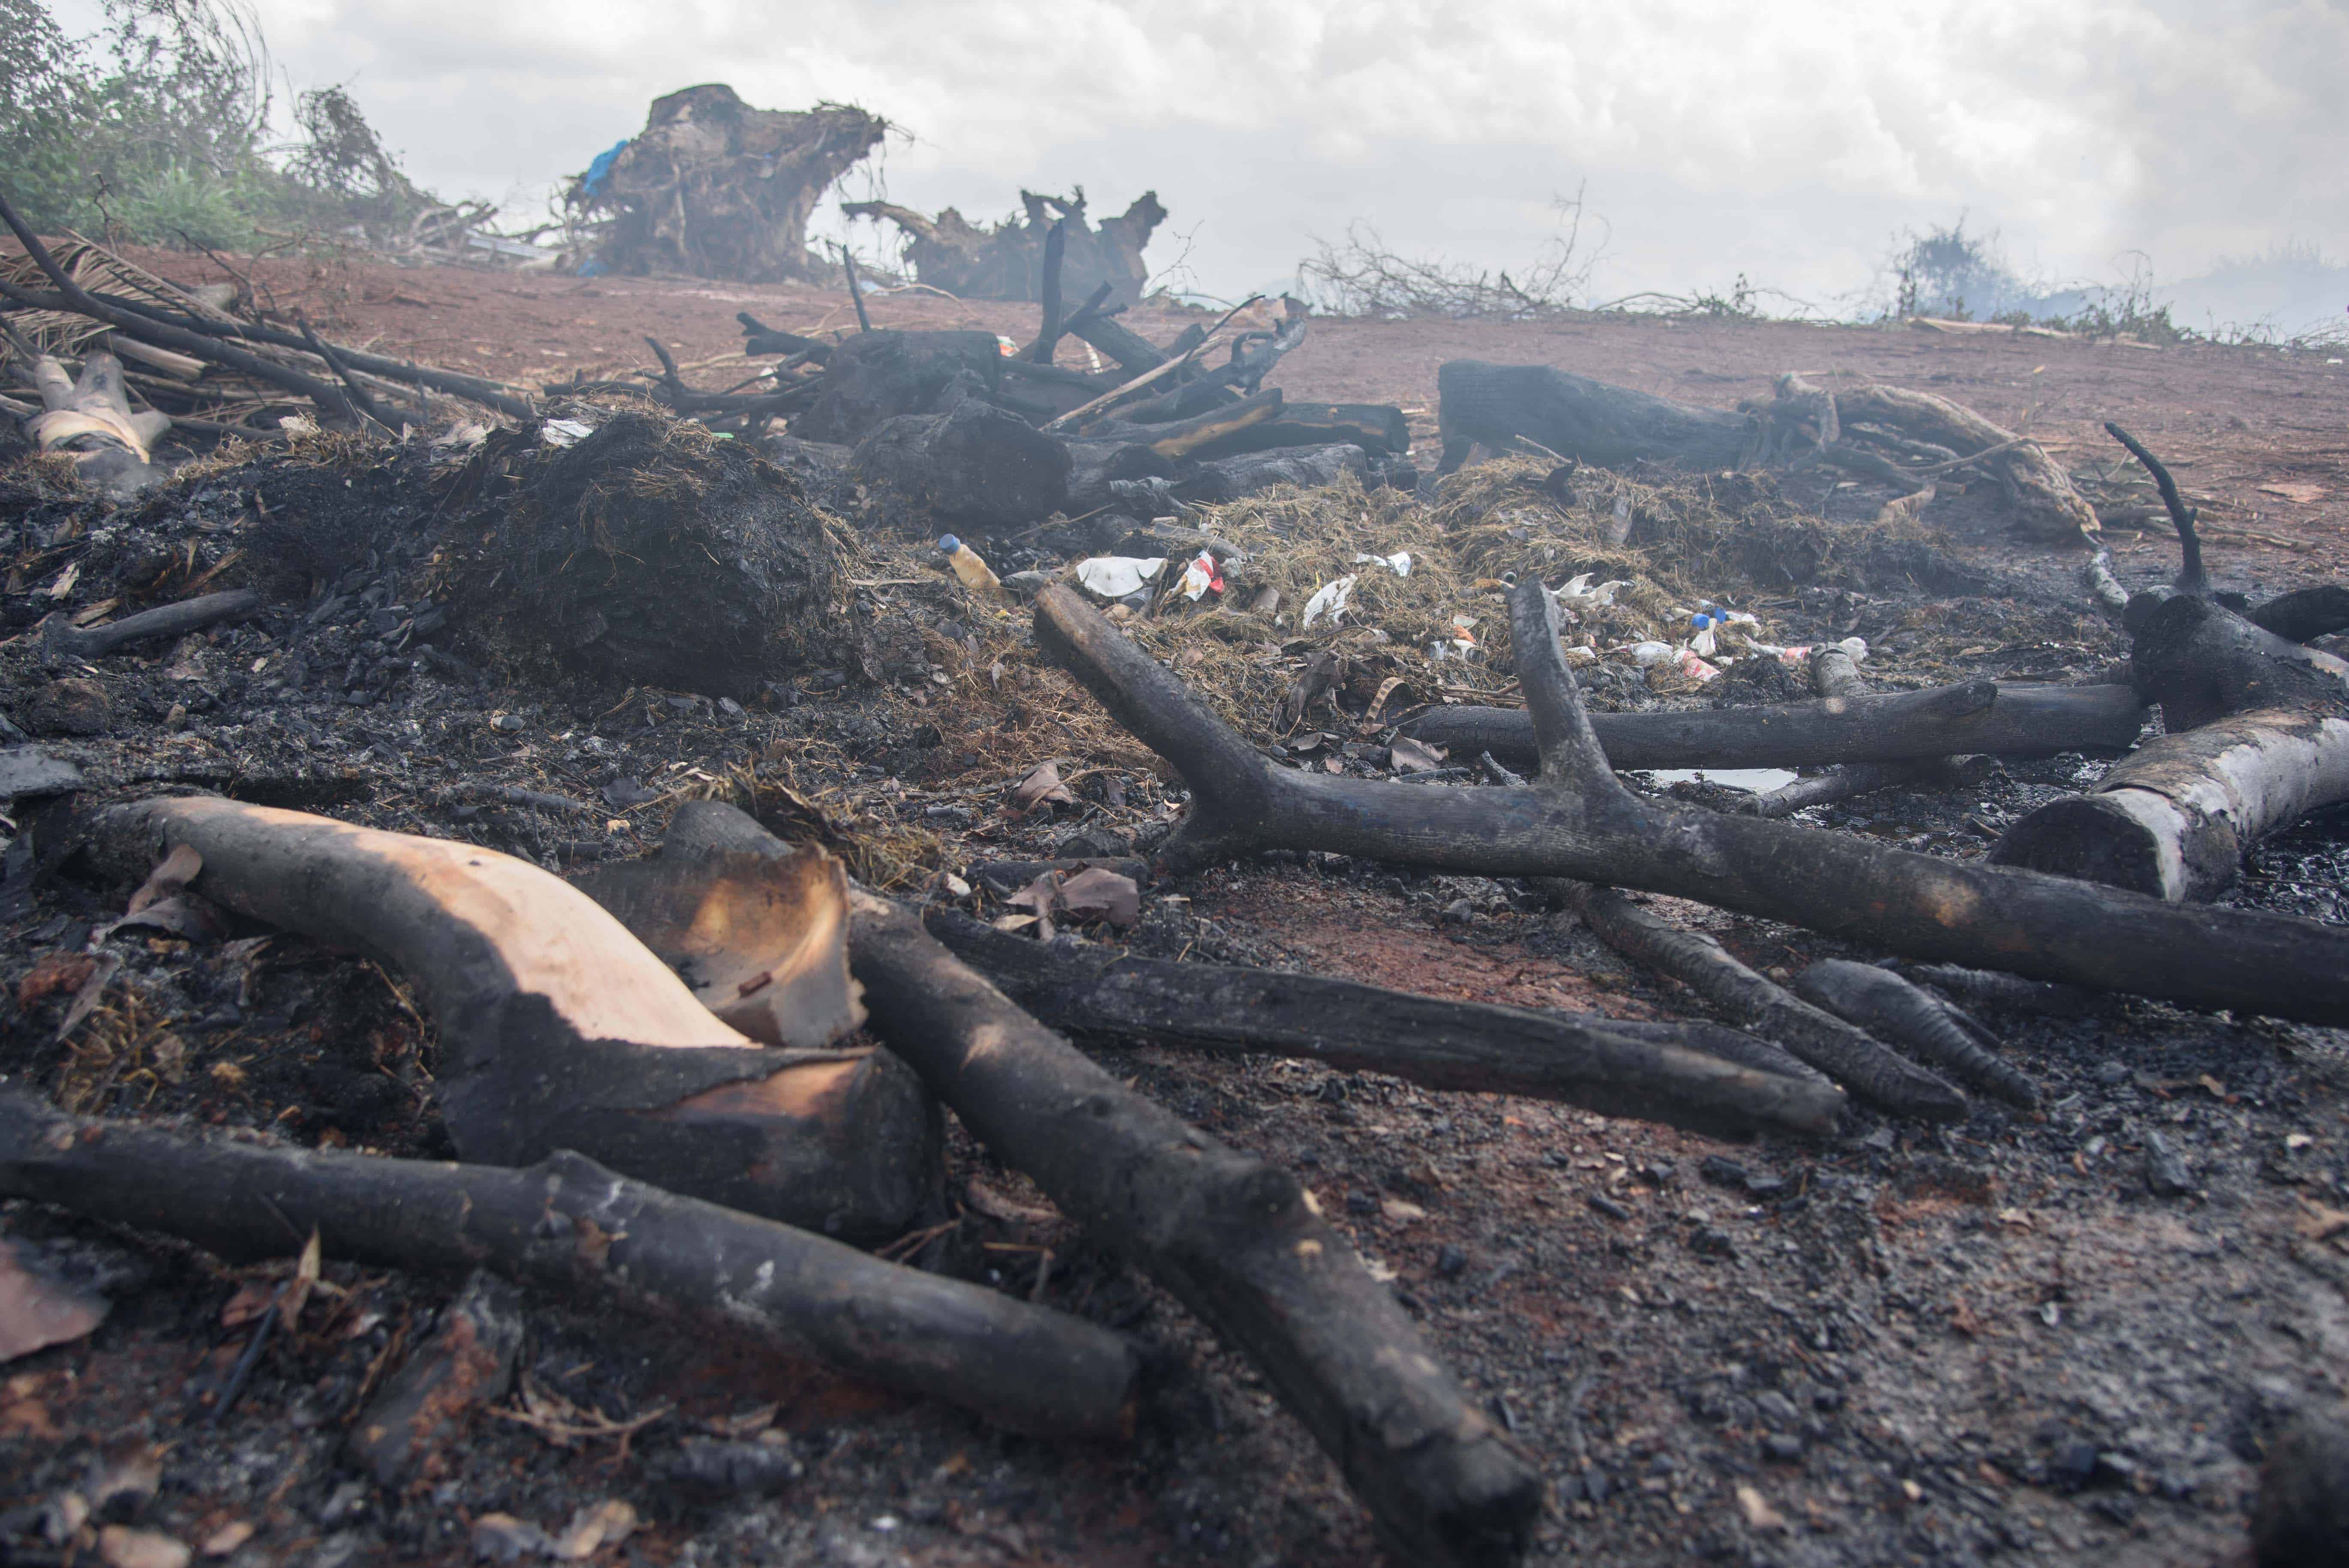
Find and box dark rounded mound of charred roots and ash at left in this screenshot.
[439,408,855,697]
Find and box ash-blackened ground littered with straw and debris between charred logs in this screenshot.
[0,359,2349,1566]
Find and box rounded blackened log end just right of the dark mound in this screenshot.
[848,397,1069,531]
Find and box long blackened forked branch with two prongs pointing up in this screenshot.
[1036,577,2349,1023]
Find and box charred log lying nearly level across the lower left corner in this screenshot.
[0,1089,1139,1437]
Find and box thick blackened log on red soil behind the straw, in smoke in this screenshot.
[1435,359,1752,474]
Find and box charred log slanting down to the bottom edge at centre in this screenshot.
[850,894,1541,1566]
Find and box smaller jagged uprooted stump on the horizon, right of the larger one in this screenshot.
[841,190,1168,307]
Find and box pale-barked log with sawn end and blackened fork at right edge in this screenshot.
[1990,594,2349,902]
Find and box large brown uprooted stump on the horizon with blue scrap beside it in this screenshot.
[566,82,888,284]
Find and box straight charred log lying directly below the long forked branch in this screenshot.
[926,908,1844,1134]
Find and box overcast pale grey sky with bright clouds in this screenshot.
[59,0,2349,310]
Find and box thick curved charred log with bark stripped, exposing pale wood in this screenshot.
[92,796,937,1237]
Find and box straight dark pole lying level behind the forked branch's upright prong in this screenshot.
[1402,681,2145,768]
